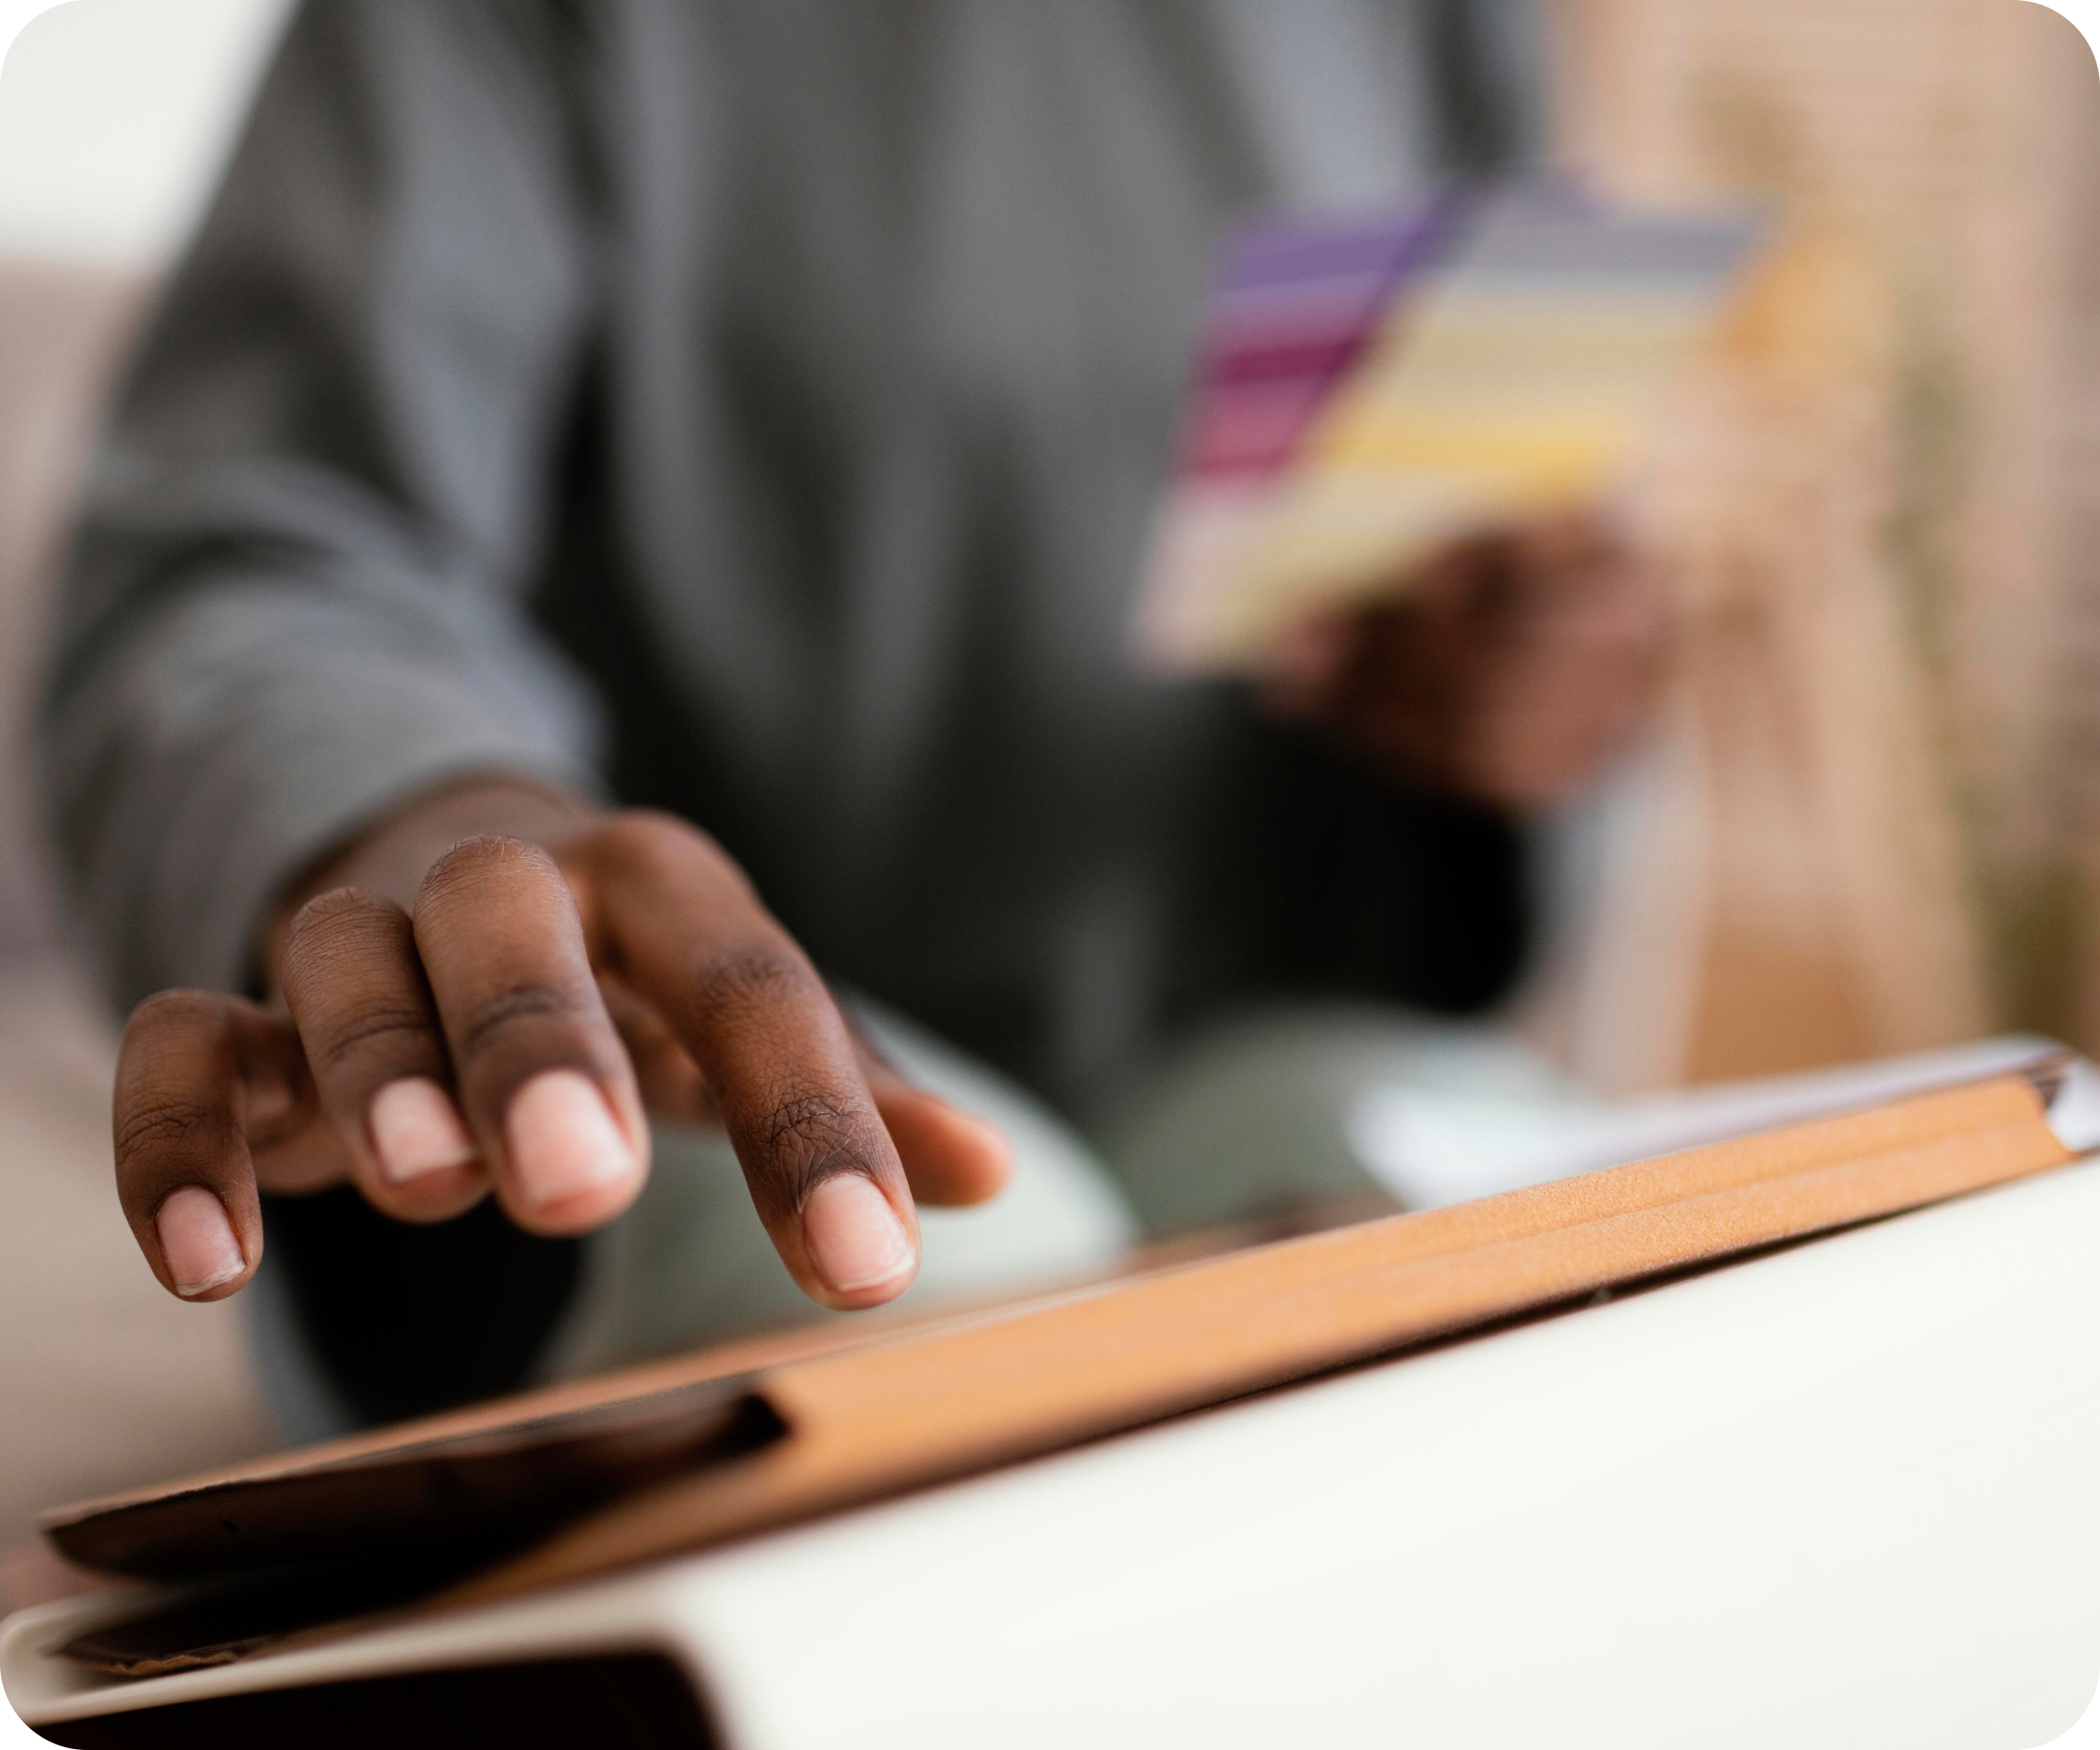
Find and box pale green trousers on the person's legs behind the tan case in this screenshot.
[548,1000,1556,1374]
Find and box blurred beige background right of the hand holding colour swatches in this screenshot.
[1556,0,2100,1086]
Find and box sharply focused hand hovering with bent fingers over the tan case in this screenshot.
[116,779,1008,1307]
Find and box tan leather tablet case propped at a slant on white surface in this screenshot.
[44,1063,2073,1674]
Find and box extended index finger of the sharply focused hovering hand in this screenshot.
[578,815,918,1307]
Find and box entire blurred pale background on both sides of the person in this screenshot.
[0,0,2100,1546]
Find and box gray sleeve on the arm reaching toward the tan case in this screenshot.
[42,0,596,1004]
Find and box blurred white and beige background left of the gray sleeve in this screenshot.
[0,0,288,1601]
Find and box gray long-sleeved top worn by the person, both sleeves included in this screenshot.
[46,0,1538,1093]
